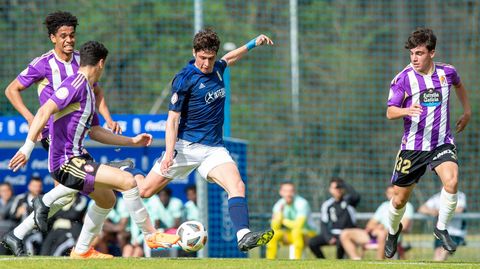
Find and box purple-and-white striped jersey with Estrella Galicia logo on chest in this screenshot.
[387,63,460,151]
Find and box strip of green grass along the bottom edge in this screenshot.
[0,256,480,269]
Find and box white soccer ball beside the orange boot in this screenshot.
[177,220,207,252]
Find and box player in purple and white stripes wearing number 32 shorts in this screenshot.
[385,28,471,258]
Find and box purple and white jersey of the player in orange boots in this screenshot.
[48,72,99,172]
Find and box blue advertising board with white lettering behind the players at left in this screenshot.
[0,115,247,257]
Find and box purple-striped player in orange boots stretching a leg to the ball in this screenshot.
[9,41,178,259]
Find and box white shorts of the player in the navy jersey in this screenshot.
[152,139,235,181]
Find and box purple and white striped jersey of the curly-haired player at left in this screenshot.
[17,50,80,138]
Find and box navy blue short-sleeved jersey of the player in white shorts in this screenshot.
[169,60,227,146]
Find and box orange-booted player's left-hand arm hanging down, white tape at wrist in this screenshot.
[8,100,59,172]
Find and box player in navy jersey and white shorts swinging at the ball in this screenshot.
[139,29,273,251]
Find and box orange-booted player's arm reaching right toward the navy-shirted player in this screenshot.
[89,125,152,147]
